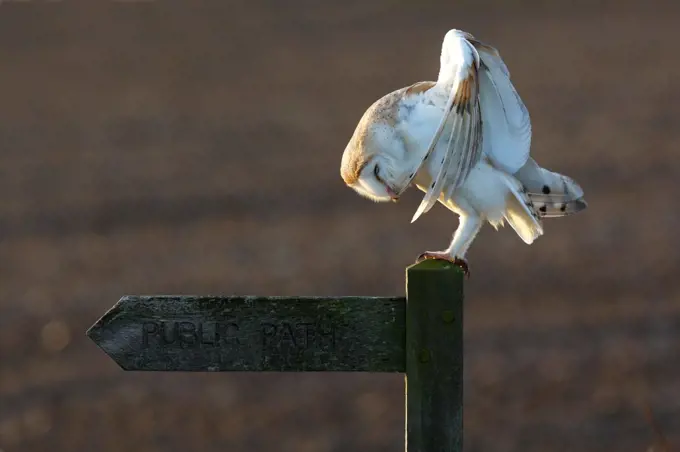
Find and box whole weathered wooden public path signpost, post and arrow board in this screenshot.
[87,260,463,452]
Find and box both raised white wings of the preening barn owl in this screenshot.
[409,29,531,222]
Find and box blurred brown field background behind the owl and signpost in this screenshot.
[0,0,680,452]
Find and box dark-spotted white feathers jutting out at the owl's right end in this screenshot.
[515,159,588,218]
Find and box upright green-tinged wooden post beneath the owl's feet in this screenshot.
[406,260,463,452]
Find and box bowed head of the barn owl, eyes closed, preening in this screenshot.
[340,123,406,202]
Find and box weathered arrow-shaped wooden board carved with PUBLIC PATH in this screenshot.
[87,296,405,372]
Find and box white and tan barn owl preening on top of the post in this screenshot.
[340,29,587,276]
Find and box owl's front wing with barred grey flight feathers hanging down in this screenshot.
[411,30,482,222]
